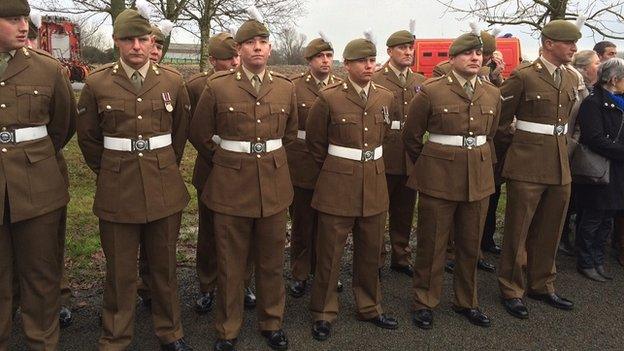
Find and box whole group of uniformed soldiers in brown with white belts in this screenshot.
[0,0,581,350]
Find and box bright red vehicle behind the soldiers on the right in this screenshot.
[412,38,522,78]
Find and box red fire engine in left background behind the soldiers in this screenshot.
[39,16,89,82]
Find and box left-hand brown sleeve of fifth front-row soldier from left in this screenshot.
[402,89,431,162]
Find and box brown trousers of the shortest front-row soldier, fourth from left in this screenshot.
[310,212,386,322]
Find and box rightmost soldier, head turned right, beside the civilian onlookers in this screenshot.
[497,20,581,318]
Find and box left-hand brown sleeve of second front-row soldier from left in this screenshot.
[76,83,104,174]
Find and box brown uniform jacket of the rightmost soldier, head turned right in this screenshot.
[496,59,579,185]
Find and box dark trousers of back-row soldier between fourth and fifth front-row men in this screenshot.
[379,174,416,268]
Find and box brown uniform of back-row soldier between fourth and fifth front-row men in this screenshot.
[373,63,425,267]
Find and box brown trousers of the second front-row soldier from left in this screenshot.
[98,212,183,351]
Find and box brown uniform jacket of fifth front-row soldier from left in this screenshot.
[403,73,501,201]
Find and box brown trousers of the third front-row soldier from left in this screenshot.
[214,210,286,339]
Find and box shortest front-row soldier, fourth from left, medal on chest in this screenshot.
[306,35,398,341]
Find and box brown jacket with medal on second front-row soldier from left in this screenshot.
[77,63,190,223]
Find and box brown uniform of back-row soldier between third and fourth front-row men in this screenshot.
[286,71,341,280]
